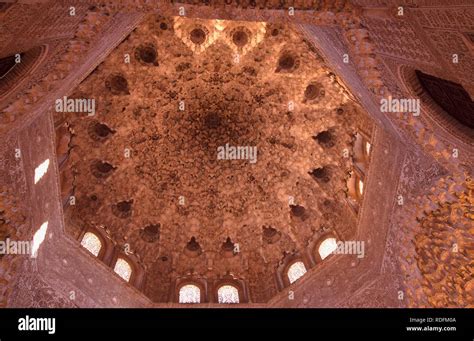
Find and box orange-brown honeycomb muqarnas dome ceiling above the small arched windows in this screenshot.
[56,16,372,302]
